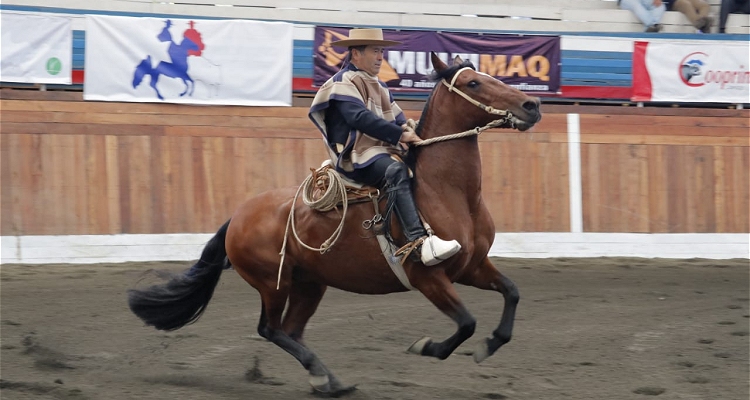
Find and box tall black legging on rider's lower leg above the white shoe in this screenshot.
[385,162,427,242]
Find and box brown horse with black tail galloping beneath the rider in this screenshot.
[129,54,541,396]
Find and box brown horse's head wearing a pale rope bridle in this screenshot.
[431,53,542,131]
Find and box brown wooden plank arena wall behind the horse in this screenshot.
[0,89,750,236]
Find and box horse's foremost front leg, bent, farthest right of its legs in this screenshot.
[458,258,520,363]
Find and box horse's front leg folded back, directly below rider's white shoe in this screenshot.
[409,272,476,360]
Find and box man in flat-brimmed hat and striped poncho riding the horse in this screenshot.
[309,29,461,266]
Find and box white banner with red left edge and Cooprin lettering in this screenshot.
[632,41,750,103]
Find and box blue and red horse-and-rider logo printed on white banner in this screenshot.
[133,20,205,100]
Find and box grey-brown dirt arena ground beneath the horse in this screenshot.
[0,258,750,400]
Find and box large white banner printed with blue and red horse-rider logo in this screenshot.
[83,15,294,106]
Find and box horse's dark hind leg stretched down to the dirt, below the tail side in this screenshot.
[258,287,351,395]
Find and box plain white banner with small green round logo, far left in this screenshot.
[0,11,73,85]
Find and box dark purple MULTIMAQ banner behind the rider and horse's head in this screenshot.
[313,26,560,94]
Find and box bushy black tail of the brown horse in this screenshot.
[128,221,231,331]
